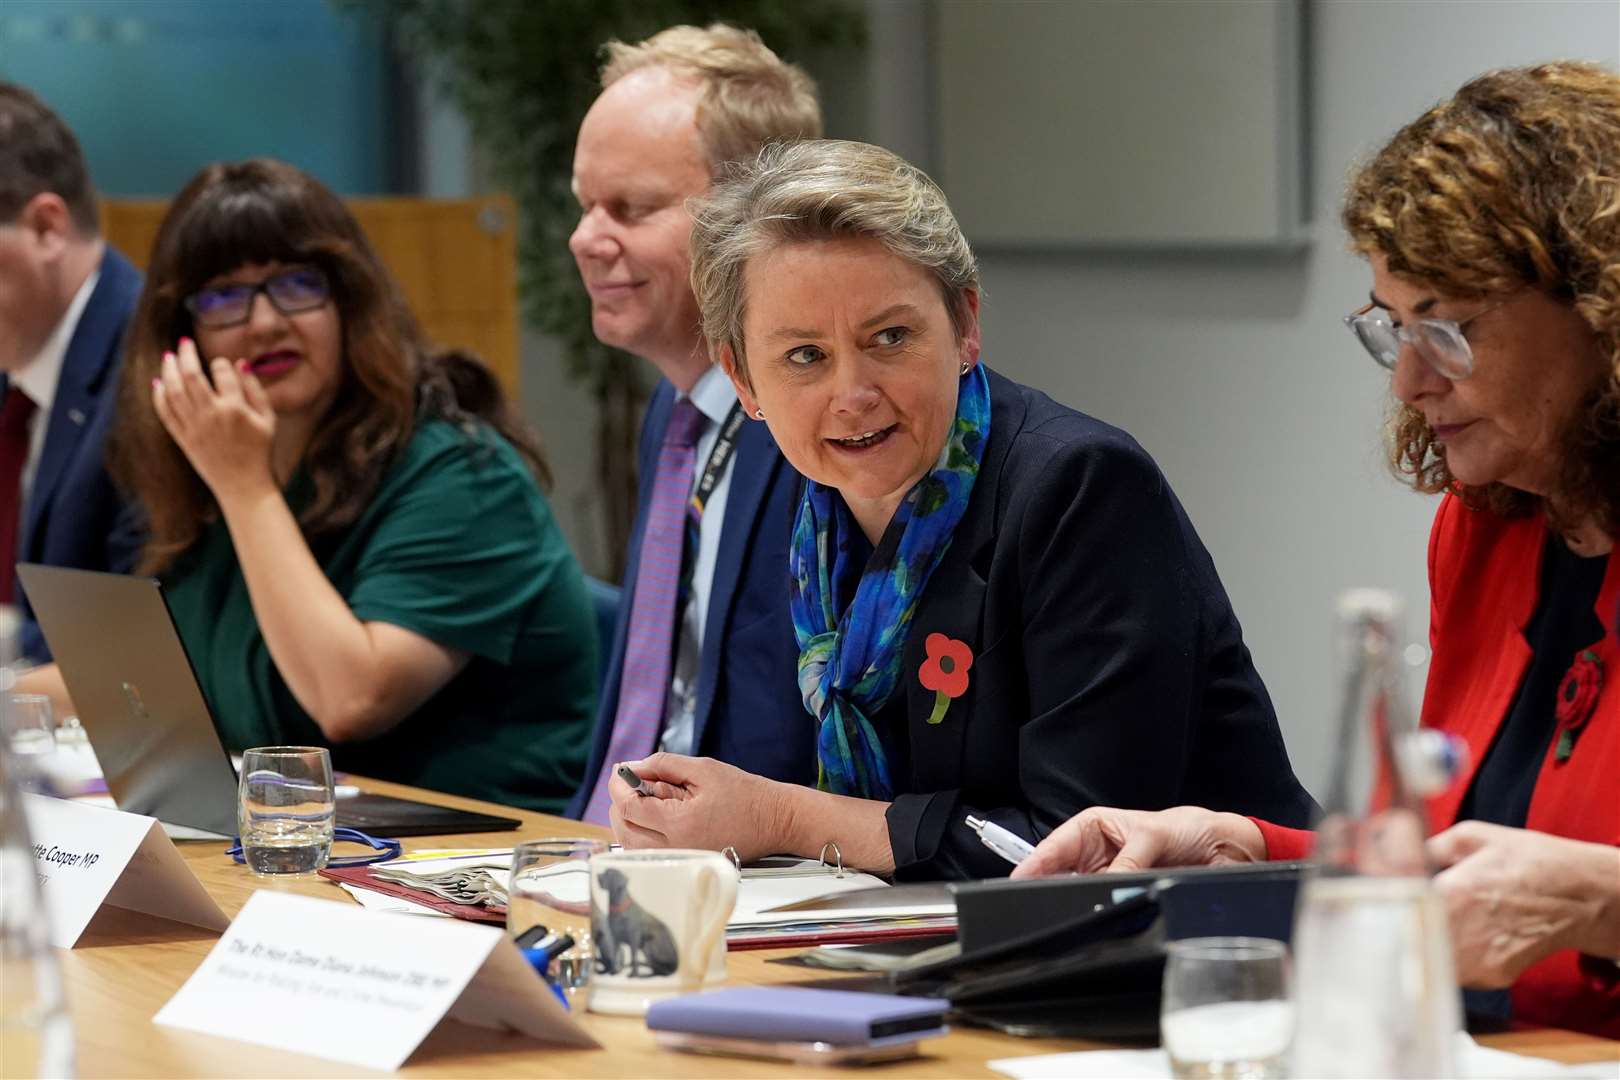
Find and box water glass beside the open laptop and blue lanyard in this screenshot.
[237,746,337,874]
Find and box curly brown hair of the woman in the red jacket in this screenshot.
[1343,62,1620,534]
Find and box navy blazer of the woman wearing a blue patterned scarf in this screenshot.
[881,372,1315,879]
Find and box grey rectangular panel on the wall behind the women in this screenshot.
[933,0,1304,248]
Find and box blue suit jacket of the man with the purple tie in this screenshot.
[569,381,815,818]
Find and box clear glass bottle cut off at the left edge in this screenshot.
[0,607,73,1077]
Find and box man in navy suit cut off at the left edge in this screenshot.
[0,83,141,661]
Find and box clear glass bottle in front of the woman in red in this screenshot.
[1291,589,1461,1077]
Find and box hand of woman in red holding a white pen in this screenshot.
[1013,806,1265,878]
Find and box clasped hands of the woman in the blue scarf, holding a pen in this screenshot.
[608,753,789,861]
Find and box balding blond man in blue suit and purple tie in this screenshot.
[569,24,821,824]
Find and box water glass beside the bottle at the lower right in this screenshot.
[1158,938,1294,1080]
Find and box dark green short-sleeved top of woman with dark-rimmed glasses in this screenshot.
[164,419,598,813]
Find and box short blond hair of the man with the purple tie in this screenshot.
[601,23,821,173]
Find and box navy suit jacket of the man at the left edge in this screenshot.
[0,244,141,662]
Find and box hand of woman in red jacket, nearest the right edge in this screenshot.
[1429,821,1620,988]
